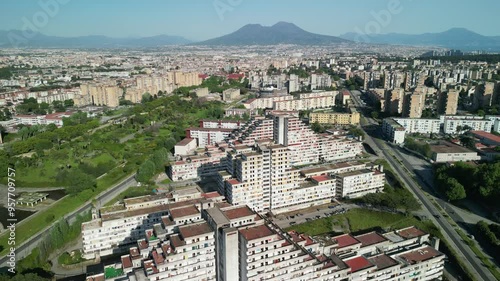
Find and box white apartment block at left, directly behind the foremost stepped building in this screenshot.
[82,188,223,259]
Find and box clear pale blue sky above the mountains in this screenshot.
[0,0,500,41]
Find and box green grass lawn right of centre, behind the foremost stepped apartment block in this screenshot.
[286,209,437,236]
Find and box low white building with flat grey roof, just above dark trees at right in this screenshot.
[431,142,481,163]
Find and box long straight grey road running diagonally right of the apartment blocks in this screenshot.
[351,89,496,280]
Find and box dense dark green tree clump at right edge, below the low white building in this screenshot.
[434,162,500,203]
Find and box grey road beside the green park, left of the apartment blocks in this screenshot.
[0,174,137,267]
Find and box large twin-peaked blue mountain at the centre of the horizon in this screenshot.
[194,22,350,46]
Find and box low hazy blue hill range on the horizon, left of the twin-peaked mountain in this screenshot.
[0,30,192,48]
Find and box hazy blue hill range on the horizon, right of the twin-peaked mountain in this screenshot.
[340,28,500,51]
